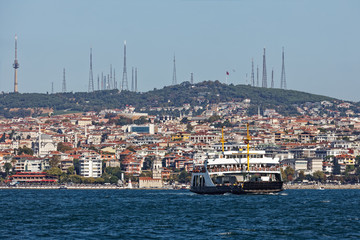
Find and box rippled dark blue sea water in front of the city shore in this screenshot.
[0,190,360,239]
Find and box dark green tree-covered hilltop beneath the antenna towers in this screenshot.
[0,81,350,117]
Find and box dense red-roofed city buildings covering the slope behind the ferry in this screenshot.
[0,100,360,188]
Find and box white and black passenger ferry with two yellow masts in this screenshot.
[190,126,283,194]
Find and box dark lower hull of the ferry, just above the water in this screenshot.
[190,182,284,194]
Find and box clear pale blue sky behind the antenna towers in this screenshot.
[0,0,360,101]
